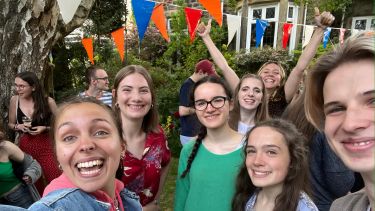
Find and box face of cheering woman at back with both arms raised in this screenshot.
[259,63,281,89]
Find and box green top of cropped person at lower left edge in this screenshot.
[0,161,21,196]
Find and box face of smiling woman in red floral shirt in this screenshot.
[117,73,152,119]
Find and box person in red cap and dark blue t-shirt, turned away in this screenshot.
[178,59,216,145]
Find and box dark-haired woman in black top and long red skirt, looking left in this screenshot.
[8,72,61,195]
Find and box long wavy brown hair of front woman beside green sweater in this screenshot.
[232,119,308,211]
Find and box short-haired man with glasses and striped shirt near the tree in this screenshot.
[79,66,112,107]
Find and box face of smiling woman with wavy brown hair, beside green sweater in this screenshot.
[245,127,290,188]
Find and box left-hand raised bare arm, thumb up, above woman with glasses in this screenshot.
[197,19,240,92]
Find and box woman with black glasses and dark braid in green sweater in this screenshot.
[174,76,243,211]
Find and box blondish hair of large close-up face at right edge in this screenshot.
[305,32,375,131]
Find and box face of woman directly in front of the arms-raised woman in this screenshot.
[238,78,263,111]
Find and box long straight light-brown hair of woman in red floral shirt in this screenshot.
[113,65,160,133]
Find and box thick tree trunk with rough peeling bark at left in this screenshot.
[0,0,95,135]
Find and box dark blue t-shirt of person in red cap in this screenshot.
[179,78,201,137]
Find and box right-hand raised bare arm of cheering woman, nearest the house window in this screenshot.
[284,8,335,102]
